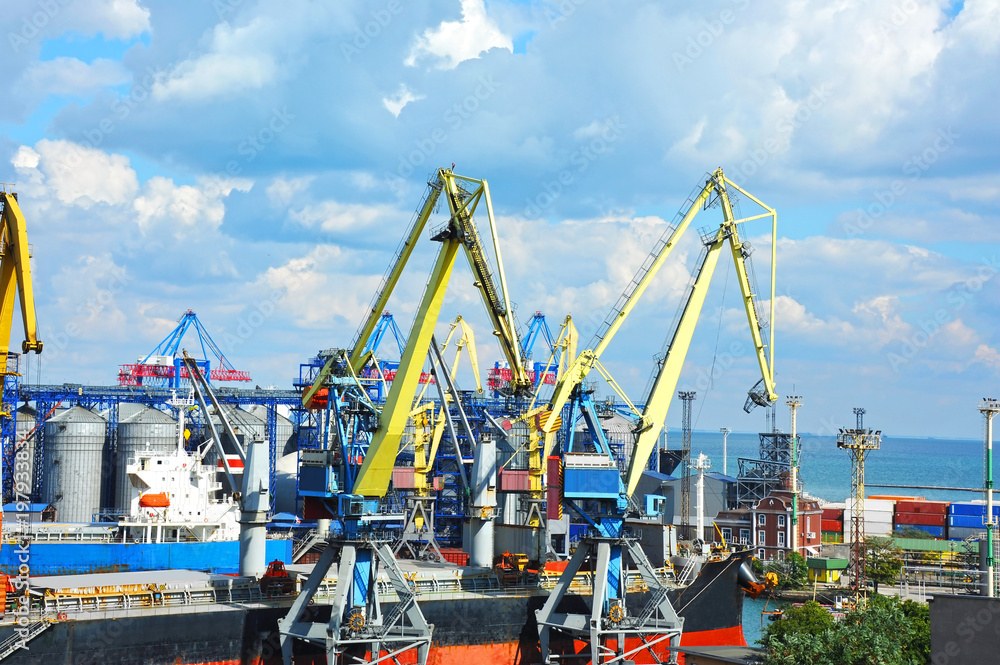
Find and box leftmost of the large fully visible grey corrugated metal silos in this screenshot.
[42,406,107,522]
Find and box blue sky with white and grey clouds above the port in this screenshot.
[0,0,1000,438]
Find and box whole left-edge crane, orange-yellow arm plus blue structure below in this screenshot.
[0,186,42,503]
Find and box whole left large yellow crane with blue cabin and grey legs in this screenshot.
[279,169,531,665]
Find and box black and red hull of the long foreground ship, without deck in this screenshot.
[0,554,748,665]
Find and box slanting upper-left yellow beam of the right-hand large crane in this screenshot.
[543,169,724,457]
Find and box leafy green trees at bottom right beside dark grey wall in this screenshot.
[762,595,930,665]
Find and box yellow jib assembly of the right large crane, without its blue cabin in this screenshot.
[543,168,778,496]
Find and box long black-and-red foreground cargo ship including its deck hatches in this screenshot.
[0,551,759,665]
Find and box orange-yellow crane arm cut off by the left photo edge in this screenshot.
[0,192,42,358]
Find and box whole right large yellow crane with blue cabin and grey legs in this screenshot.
[536,169,777,665]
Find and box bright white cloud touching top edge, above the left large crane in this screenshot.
[406,0,514,69]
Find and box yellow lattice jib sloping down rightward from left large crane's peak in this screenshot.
[444,171,531,390]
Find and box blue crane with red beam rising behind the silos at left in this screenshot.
[118,309,250,388]
